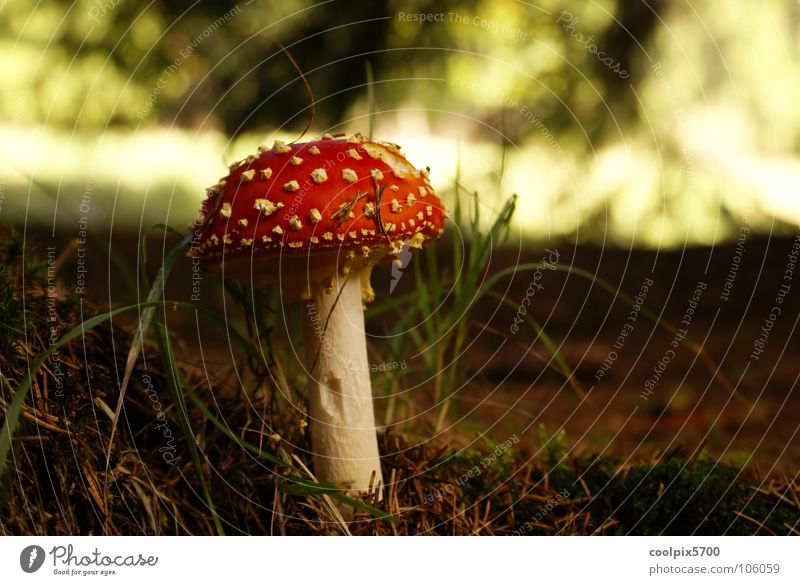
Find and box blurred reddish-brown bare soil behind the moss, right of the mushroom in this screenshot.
[450,238,800,477]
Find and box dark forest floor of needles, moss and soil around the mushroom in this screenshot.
[0,227,800,534]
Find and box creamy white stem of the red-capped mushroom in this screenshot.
[303,268,383,494]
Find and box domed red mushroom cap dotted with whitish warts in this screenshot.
[192,134,445,261]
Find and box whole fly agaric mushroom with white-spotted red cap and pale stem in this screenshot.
[192,134,445,502]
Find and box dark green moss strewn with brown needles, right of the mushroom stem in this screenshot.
[412,429,800,535]
